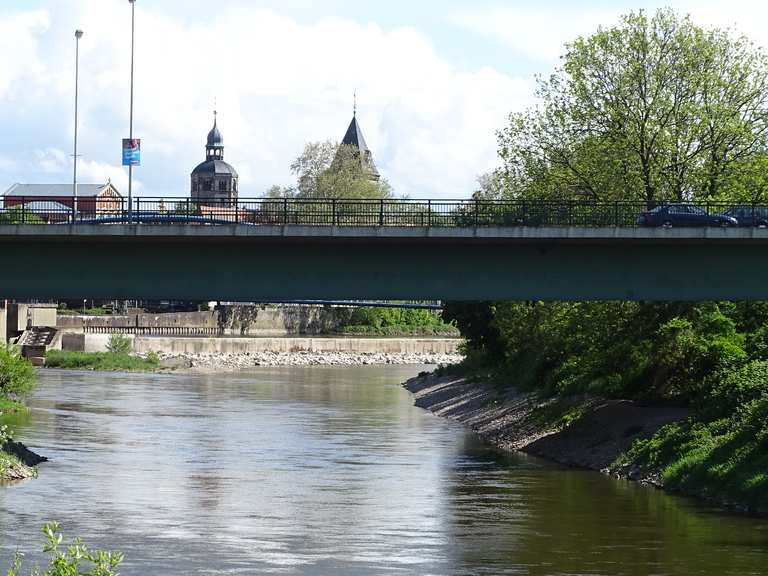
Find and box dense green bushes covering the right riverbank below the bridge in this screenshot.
[445,302,768,511]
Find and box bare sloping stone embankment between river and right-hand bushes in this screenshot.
[404,375,688,485]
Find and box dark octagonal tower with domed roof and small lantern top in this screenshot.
[190,112,238,206]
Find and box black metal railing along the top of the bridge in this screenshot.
[0,196,768,228]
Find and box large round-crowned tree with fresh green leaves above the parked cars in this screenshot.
[499,9,768,204]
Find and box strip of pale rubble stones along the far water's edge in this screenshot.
[159,352,463,371]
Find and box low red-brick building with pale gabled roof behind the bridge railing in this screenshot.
[2,181,123,221]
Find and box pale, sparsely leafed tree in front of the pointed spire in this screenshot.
[267,141,392,200]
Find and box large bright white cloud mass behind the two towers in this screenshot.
[0,0,531,197]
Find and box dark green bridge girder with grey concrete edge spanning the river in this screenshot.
[0,226,768,302]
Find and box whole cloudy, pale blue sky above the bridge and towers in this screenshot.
[0,0,768,198]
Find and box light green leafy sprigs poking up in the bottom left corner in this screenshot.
[7,523,123,576]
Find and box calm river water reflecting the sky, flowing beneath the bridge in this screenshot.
[0,367,768,576]
